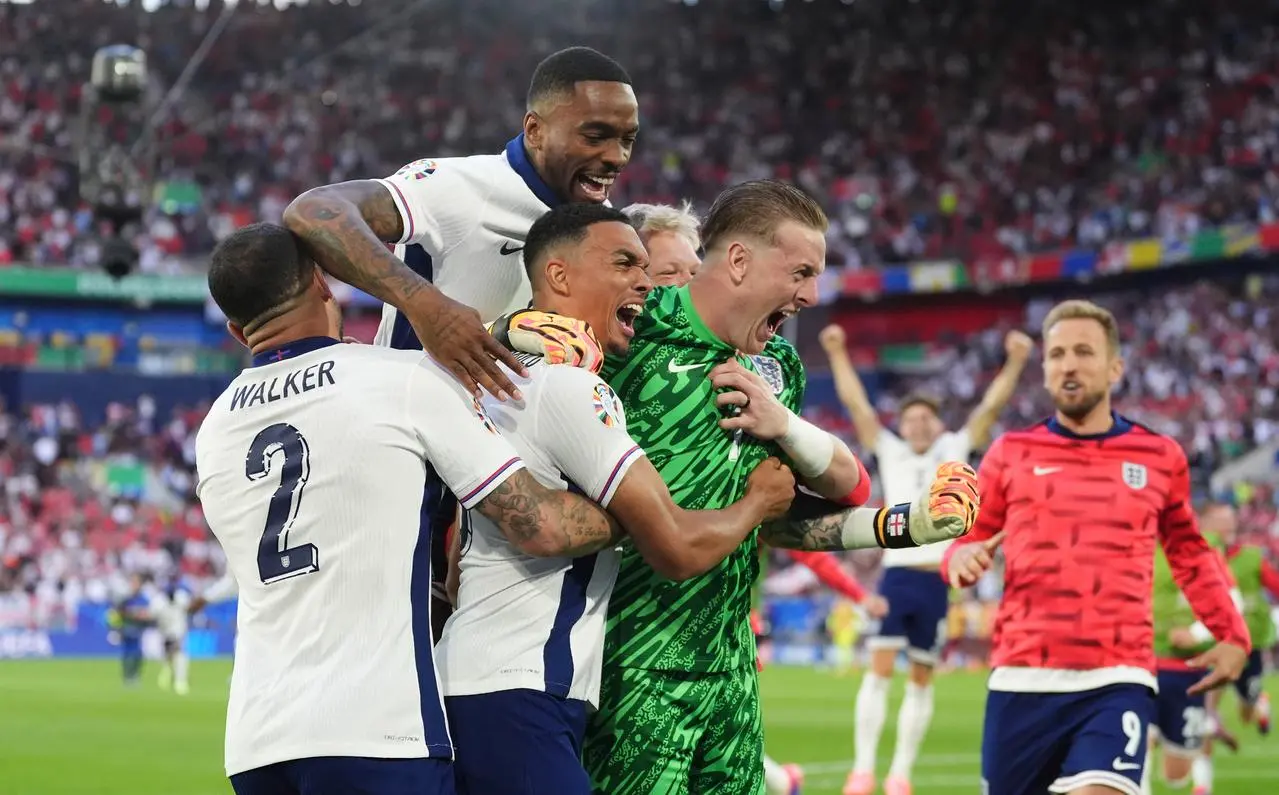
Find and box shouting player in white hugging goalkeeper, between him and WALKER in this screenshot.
[437,203,794,795]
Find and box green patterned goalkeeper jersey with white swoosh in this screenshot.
[601,286,804,672]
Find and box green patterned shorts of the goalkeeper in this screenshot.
[583,666,764,795]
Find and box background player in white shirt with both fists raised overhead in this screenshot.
[820,325,1033,795]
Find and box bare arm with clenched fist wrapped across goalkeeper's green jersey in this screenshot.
[609,458,794,582]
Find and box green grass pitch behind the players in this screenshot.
[0,661,1279,795]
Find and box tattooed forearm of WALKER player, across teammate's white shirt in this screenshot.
[476,470,622,557]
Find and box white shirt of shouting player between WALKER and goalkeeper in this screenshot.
[436,357,643,706]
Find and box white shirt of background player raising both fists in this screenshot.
[875,428,972,569]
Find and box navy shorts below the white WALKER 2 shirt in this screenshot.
[231,757,457,795]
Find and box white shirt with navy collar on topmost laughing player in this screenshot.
[373,134,560,349]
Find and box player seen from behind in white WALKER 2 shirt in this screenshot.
[196,224,618,795]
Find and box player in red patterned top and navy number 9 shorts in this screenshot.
[941,300,1250,795]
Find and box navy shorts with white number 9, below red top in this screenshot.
[981,684,1155,795]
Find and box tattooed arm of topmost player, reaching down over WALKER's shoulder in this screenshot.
[284,180,524,398]
